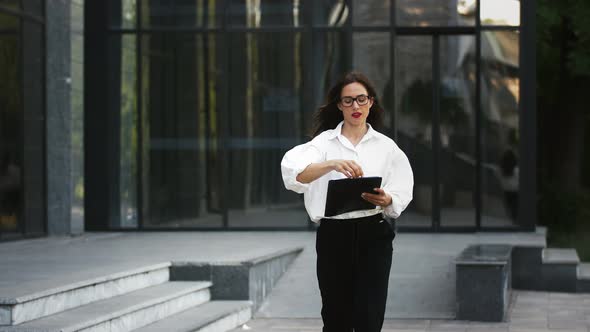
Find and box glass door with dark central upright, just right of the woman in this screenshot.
[394,33,477,230]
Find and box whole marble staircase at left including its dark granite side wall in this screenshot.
[0,248,302,332]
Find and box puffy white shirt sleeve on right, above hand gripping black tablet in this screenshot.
[383,148,414,219]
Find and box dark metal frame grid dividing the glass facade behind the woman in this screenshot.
[98,0,536,232]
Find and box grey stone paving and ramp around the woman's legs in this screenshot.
[0,232,590,332]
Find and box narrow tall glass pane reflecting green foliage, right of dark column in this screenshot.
[109,35,138,228]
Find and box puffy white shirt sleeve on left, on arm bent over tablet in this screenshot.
[281,142,323,194]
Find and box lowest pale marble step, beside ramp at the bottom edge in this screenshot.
[137,301,252,332]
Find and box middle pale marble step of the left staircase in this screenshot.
[0,281,211,332]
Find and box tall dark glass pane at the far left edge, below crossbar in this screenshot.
[0,35,23,239]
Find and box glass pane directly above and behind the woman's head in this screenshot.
[352,32,393,131]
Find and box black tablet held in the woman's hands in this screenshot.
[324,176,381,217]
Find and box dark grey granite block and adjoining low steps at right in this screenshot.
[455,244,590,322]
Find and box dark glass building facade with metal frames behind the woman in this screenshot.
[0,0,535,238]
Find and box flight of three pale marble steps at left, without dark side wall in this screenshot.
[0,263,252,332]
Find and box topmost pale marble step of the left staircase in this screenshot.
[0,262,171,326]
